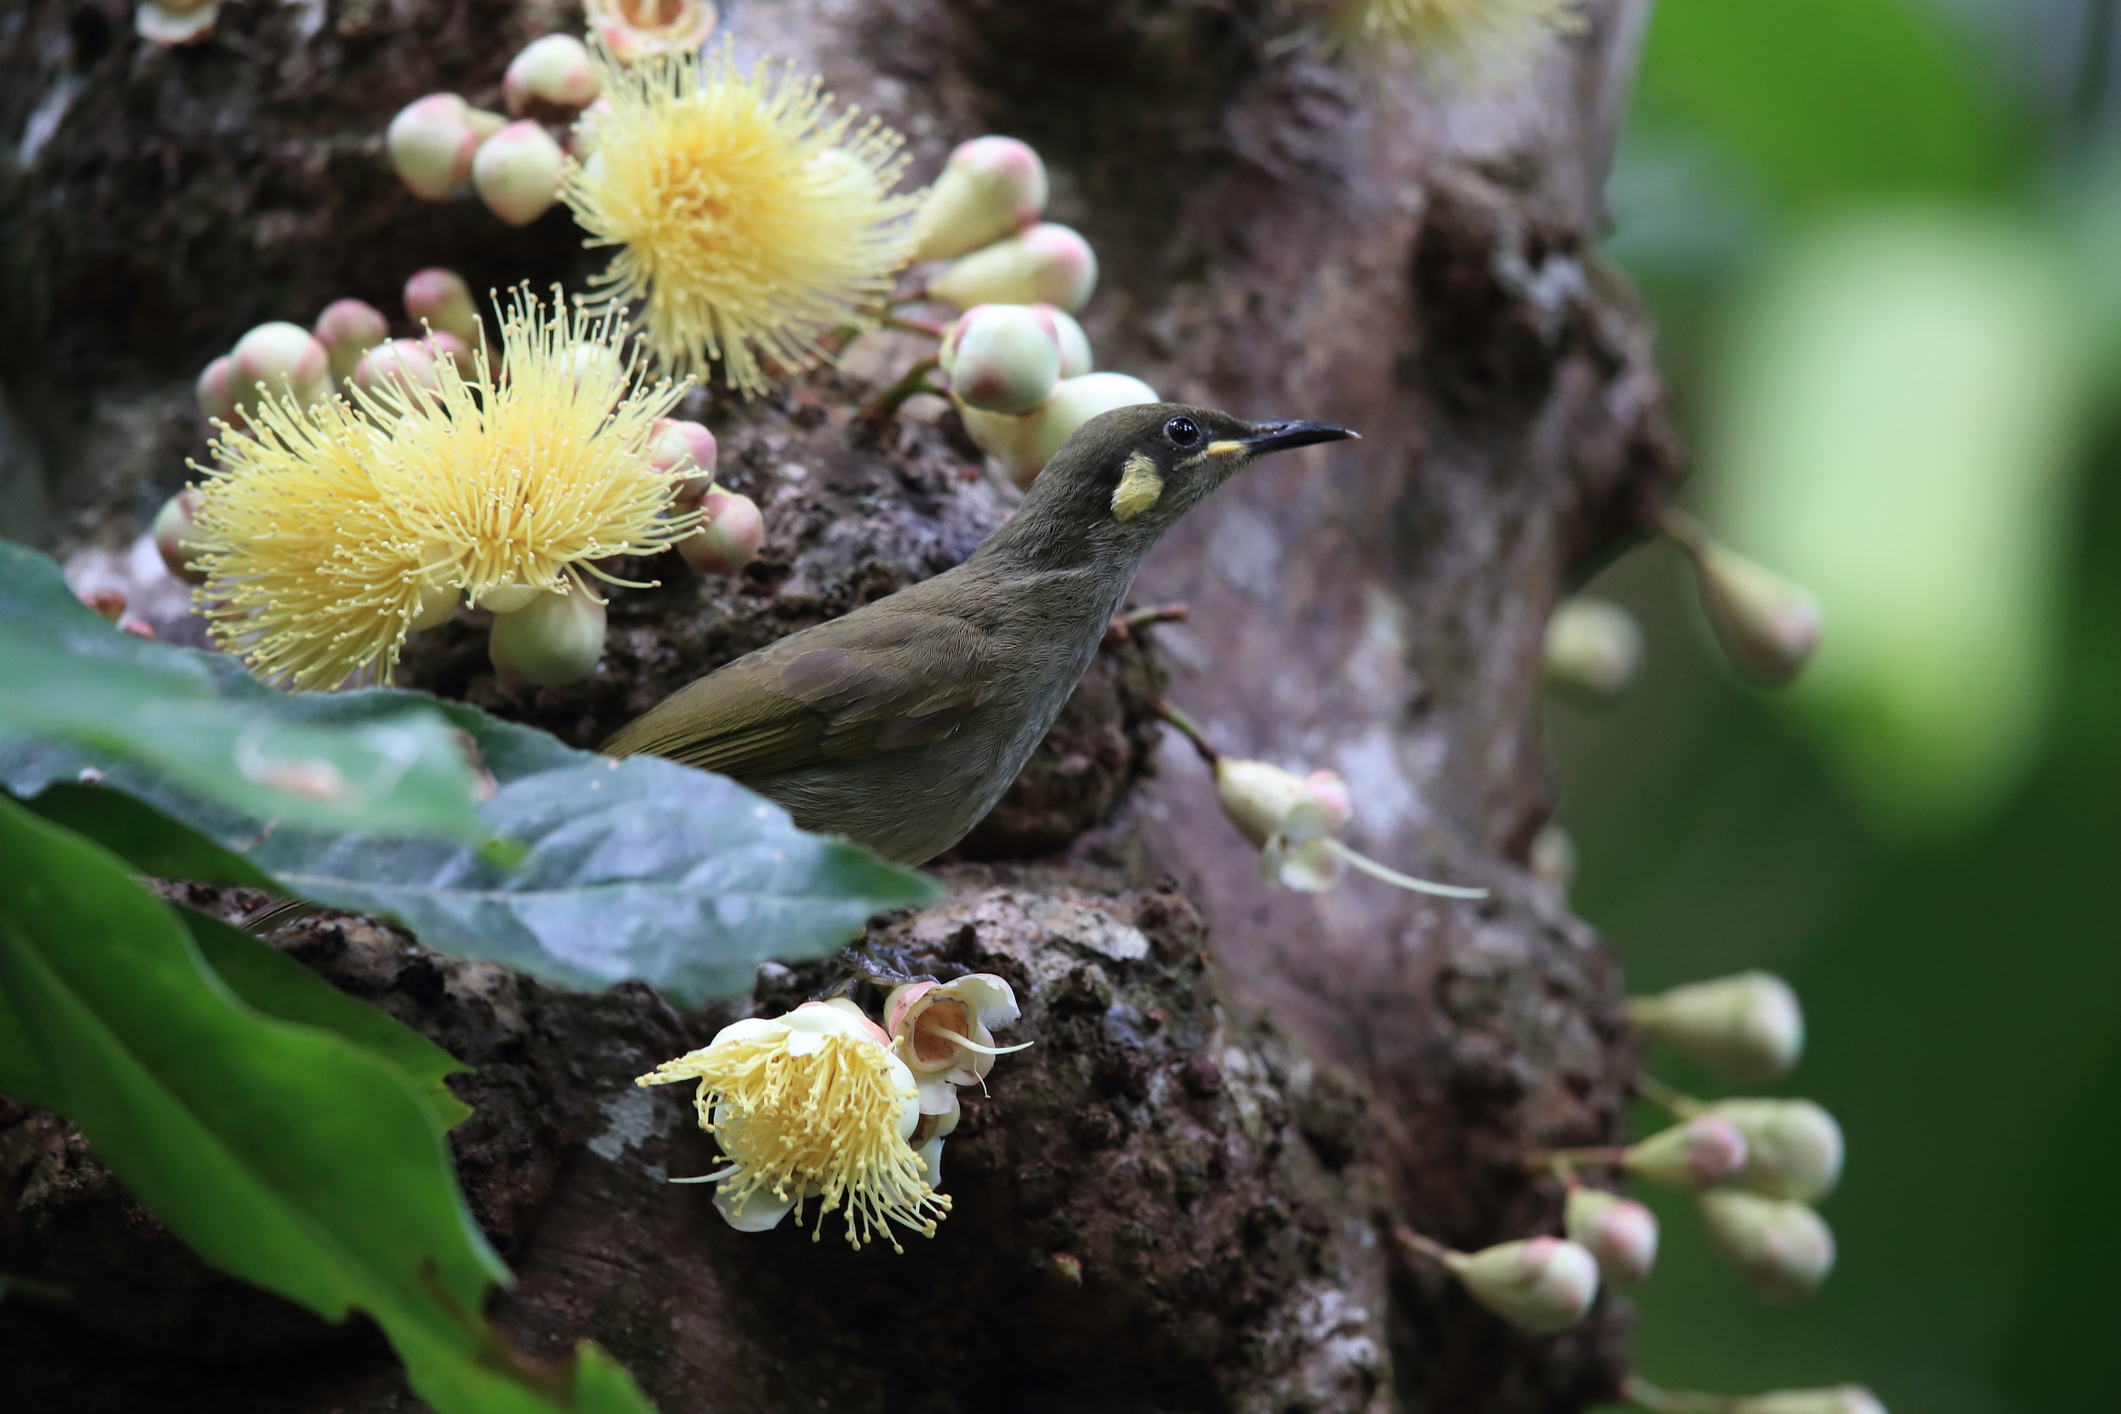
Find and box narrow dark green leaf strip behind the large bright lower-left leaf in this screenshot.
[178,907,471,1130]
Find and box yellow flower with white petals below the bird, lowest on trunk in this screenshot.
[634,998,950,1251]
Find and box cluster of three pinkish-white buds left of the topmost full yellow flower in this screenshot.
[384,34,598,227]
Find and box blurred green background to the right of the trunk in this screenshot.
[1550,0,2121,1414]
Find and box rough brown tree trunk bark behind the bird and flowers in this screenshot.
[0,0,1671,1414]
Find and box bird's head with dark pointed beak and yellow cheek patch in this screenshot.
[1016,403,1355,549]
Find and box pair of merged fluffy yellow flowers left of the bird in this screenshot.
[193,290,698,689]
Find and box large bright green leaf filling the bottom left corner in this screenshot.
[0,799,647,1414]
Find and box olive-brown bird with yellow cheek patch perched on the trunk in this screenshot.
[604,403,1355,865]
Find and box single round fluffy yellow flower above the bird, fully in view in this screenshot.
[560,45,918,394]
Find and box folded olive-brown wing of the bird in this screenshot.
[604,606,988,780]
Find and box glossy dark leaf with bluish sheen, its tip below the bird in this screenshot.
[0,545,940,1001]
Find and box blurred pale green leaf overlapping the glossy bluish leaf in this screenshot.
[0,543,479,839]
